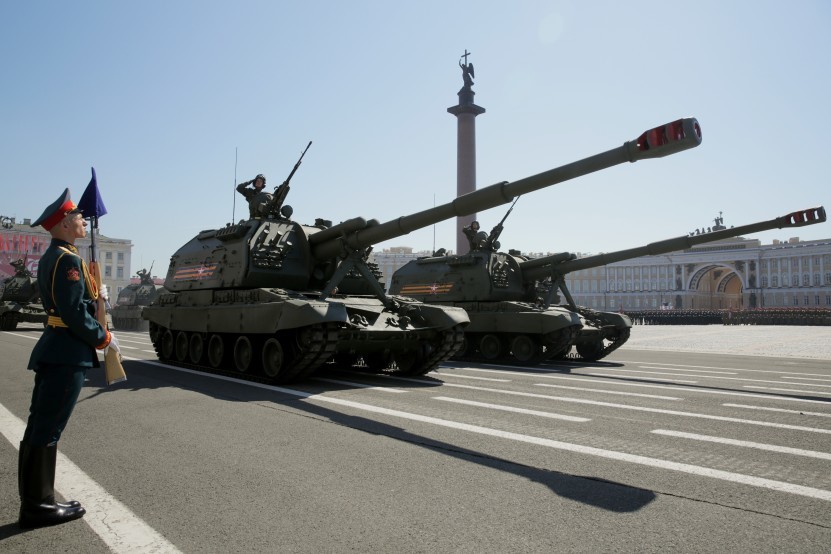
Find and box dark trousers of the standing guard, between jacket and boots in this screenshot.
[23,365,87,447]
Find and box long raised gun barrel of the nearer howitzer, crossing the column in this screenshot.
[312,118,701,260]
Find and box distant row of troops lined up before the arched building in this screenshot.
[626,307,831,326]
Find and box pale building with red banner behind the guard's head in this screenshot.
[0,217,133,299]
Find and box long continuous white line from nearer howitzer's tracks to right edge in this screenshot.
[125,361,831,501]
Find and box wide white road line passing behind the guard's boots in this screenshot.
[0,404,179,553]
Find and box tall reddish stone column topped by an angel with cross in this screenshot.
[447,49,485,254]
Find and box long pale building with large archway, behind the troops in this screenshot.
[566,233,831,311]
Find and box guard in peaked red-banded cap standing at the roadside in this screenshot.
[18,189,119,529]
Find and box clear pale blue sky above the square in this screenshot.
[0,0,831,276]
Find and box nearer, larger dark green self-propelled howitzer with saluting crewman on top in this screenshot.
[142,118,701,382]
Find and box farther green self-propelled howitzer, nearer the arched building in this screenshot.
[390,207,826,364]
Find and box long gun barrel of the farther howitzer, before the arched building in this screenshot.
[520,206,826,280]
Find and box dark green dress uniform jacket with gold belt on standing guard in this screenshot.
[29,238,108,369]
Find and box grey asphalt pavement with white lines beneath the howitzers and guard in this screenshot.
[0,325,831,554]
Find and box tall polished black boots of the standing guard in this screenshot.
[18,445,87,529]
